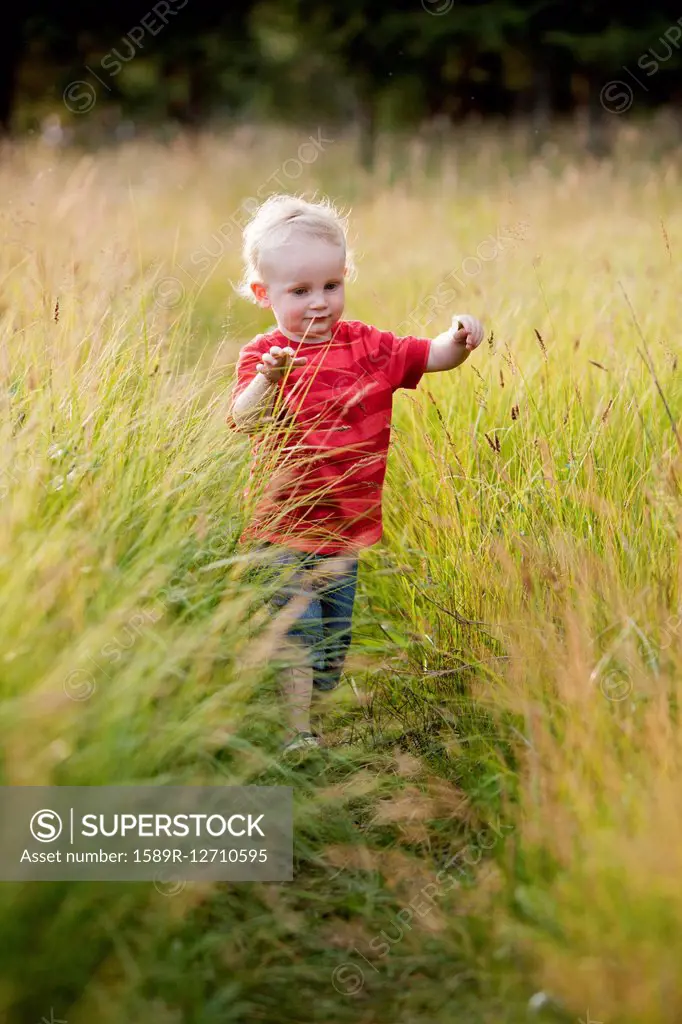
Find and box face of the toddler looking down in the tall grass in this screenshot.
[251,238,345,341]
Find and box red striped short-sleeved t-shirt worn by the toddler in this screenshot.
[227,321,431,554]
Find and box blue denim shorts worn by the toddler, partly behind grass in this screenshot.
[254,541,358,690]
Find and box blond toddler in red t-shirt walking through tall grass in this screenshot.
[227,196,483,751]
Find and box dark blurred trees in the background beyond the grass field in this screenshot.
[0,0,682,161]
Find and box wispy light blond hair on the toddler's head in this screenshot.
[237,195,355,302]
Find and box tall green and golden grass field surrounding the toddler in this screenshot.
[0,125,682,1024]
